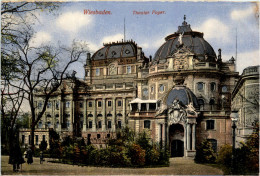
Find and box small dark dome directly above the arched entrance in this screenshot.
[165,85,199,109]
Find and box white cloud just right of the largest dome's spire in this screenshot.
[194,18,231,43]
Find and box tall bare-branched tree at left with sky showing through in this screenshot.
[1,2,87,153]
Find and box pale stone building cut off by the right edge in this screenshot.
[232,66,260,146]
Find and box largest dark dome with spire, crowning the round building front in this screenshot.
[153,17,216,62]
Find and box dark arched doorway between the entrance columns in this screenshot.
[169,124,184,157]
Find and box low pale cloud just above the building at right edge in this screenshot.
[222,50,260,74]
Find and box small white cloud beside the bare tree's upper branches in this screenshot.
[29,31,52,47]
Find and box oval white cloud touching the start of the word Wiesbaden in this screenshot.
[56,12,93,32]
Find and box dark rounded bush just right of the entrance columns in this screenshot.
[194,140,216,163]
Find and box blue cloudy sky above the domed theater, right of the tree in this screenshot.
[27,1,259,78]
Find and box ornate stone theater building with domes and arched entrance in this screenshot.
[21,19,242,157]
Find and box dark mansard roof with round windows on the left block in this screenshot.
[92,41,137,60]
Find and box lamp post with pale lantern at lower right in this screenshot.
[230,111,238,174]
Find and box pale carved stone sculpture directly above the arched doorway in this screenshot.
[168,99,187,124]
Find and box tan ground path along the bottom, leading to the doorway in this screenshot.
[1,156,223,175]
